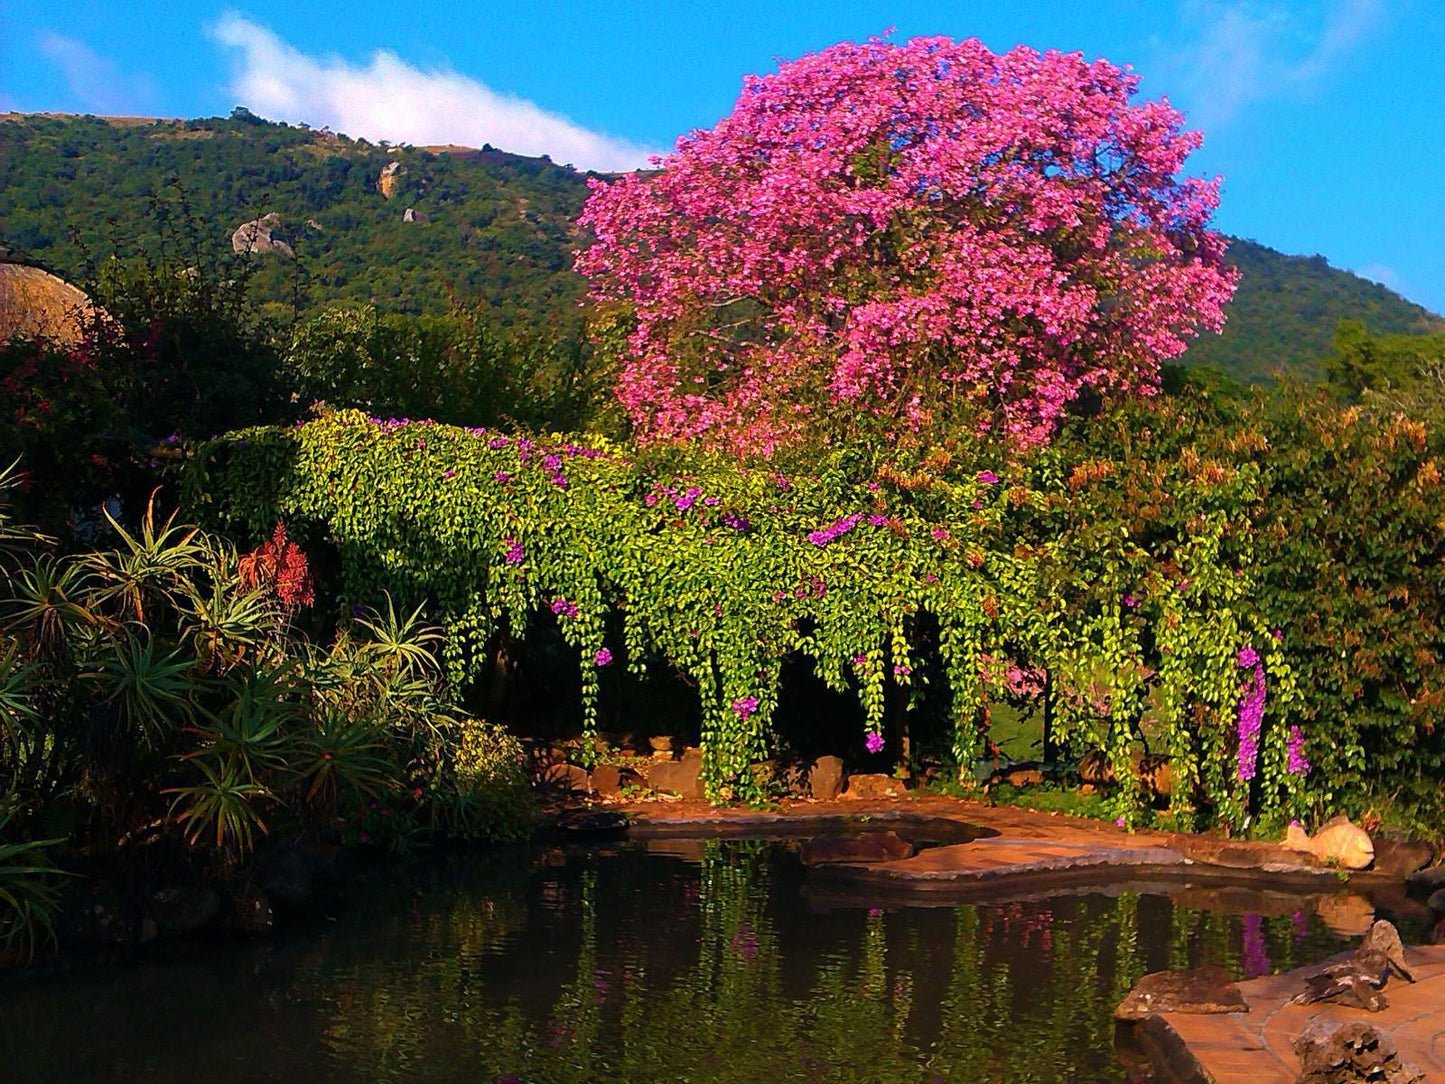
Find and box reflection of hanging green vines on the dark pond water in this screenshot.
[268,843,1337,1084]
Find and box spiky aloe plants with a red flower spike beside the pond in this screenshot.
[0,471,530,944]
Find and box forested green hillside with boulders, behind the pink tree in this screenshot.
[0,110,1445,380]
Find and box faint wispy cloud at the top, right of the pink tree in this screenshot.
[1160,0,1384,127]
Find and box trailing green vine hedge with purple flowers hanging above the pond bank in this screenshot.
[189,408,1299,821]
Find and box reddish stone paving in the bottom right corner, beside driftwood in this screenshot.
[1143,945,1445,1084]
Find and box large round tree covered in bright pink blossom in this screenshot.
[578,38,1237,451]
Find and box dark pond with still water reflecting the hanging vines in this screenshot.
[0,840,1398,1084]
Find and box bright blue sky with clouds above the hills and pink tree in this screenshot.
[0,0,1445,312]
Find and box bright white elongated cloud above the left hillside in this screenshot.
[211,13,657,171]
